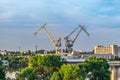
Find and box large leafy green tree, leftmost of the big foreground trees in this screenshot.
[22,55,63,80]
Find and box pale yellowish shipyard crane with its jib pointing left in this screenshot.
[34,24,63,54]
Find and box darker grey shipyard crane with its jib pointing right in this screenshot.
[64,25,89,52]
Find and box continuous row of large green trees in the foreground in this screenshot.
[18,55,110,80]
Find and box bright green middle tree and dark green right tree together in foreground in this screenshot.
[50,57,110,80]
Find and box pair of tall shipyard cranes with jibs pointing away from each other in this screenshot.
[34,24,89,53]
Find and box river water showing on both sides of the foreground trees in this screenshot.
[6,66,120,80]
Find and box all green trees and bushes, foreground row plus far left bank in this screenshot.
[0,50,110,80]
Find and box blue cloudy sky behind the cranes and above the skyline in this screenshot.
[0,0,120,51]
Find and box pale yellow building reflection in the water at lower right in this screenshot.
[111,66,120,80]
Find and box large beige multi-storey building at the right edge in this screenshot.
[94,45,120,57]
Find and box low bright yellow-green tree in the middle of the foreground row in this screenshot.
[50,64,87,80]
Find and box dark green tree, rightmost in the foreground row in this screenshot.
[83,57,110,80]
